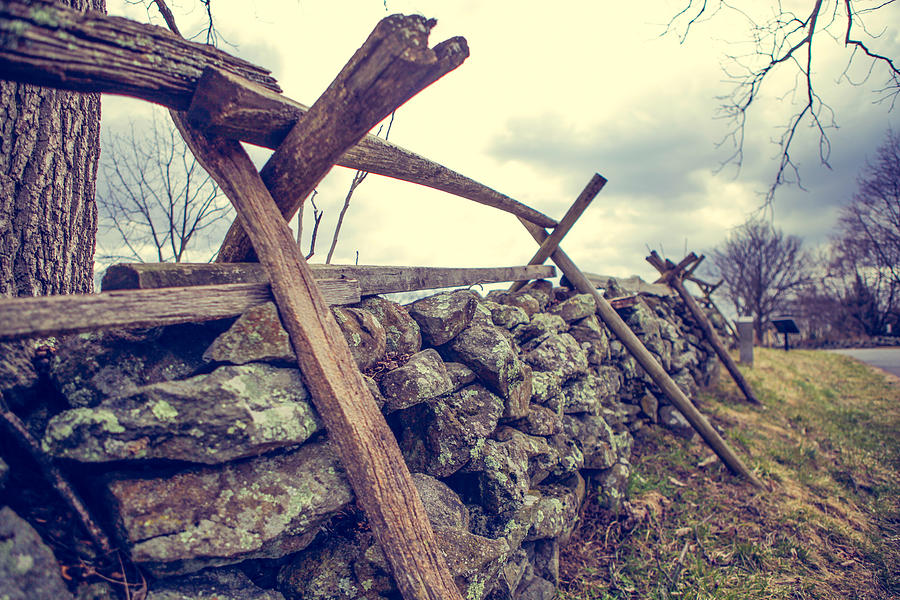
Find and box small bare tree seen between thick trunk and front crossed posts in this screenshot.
[97,118,232,262]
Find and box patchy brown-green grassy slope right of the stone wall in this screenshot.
[559,349,900,600]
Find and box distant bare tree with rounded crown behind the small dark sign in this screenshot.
[710,218,811,339]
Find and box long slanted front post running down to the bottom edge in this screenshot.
[173,129,461,600]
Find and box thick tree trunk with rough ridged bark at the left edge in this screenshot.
[0,0,106,296]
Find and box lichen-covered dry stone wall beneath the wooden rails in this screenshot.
[0,281,718,600]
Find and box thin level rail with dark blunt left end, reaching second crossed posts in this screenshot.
[101,263,556,296]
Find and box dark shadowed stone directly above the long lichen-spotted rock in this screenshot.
[50,324,220,407]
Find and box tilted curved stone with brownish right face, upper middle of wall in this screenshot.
[449,325,531,416]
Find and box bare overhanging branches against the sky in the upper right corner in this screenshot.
[666,0,900,201]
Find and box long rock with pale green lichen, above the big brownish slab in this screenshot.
[43,363,322,464]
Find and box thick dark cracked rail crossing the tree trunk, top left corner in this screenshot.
[0,0,281,110]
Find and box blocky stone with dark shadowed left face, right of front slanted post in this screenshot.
[396,383,504,477]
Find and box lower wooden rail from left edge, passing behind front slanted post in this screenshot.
[0,279,360,340]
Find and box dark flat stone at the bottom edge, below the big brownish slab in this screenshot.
[147,568,284,600]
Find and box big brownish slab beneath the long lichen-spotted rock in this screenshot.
[107,443,353,576]
